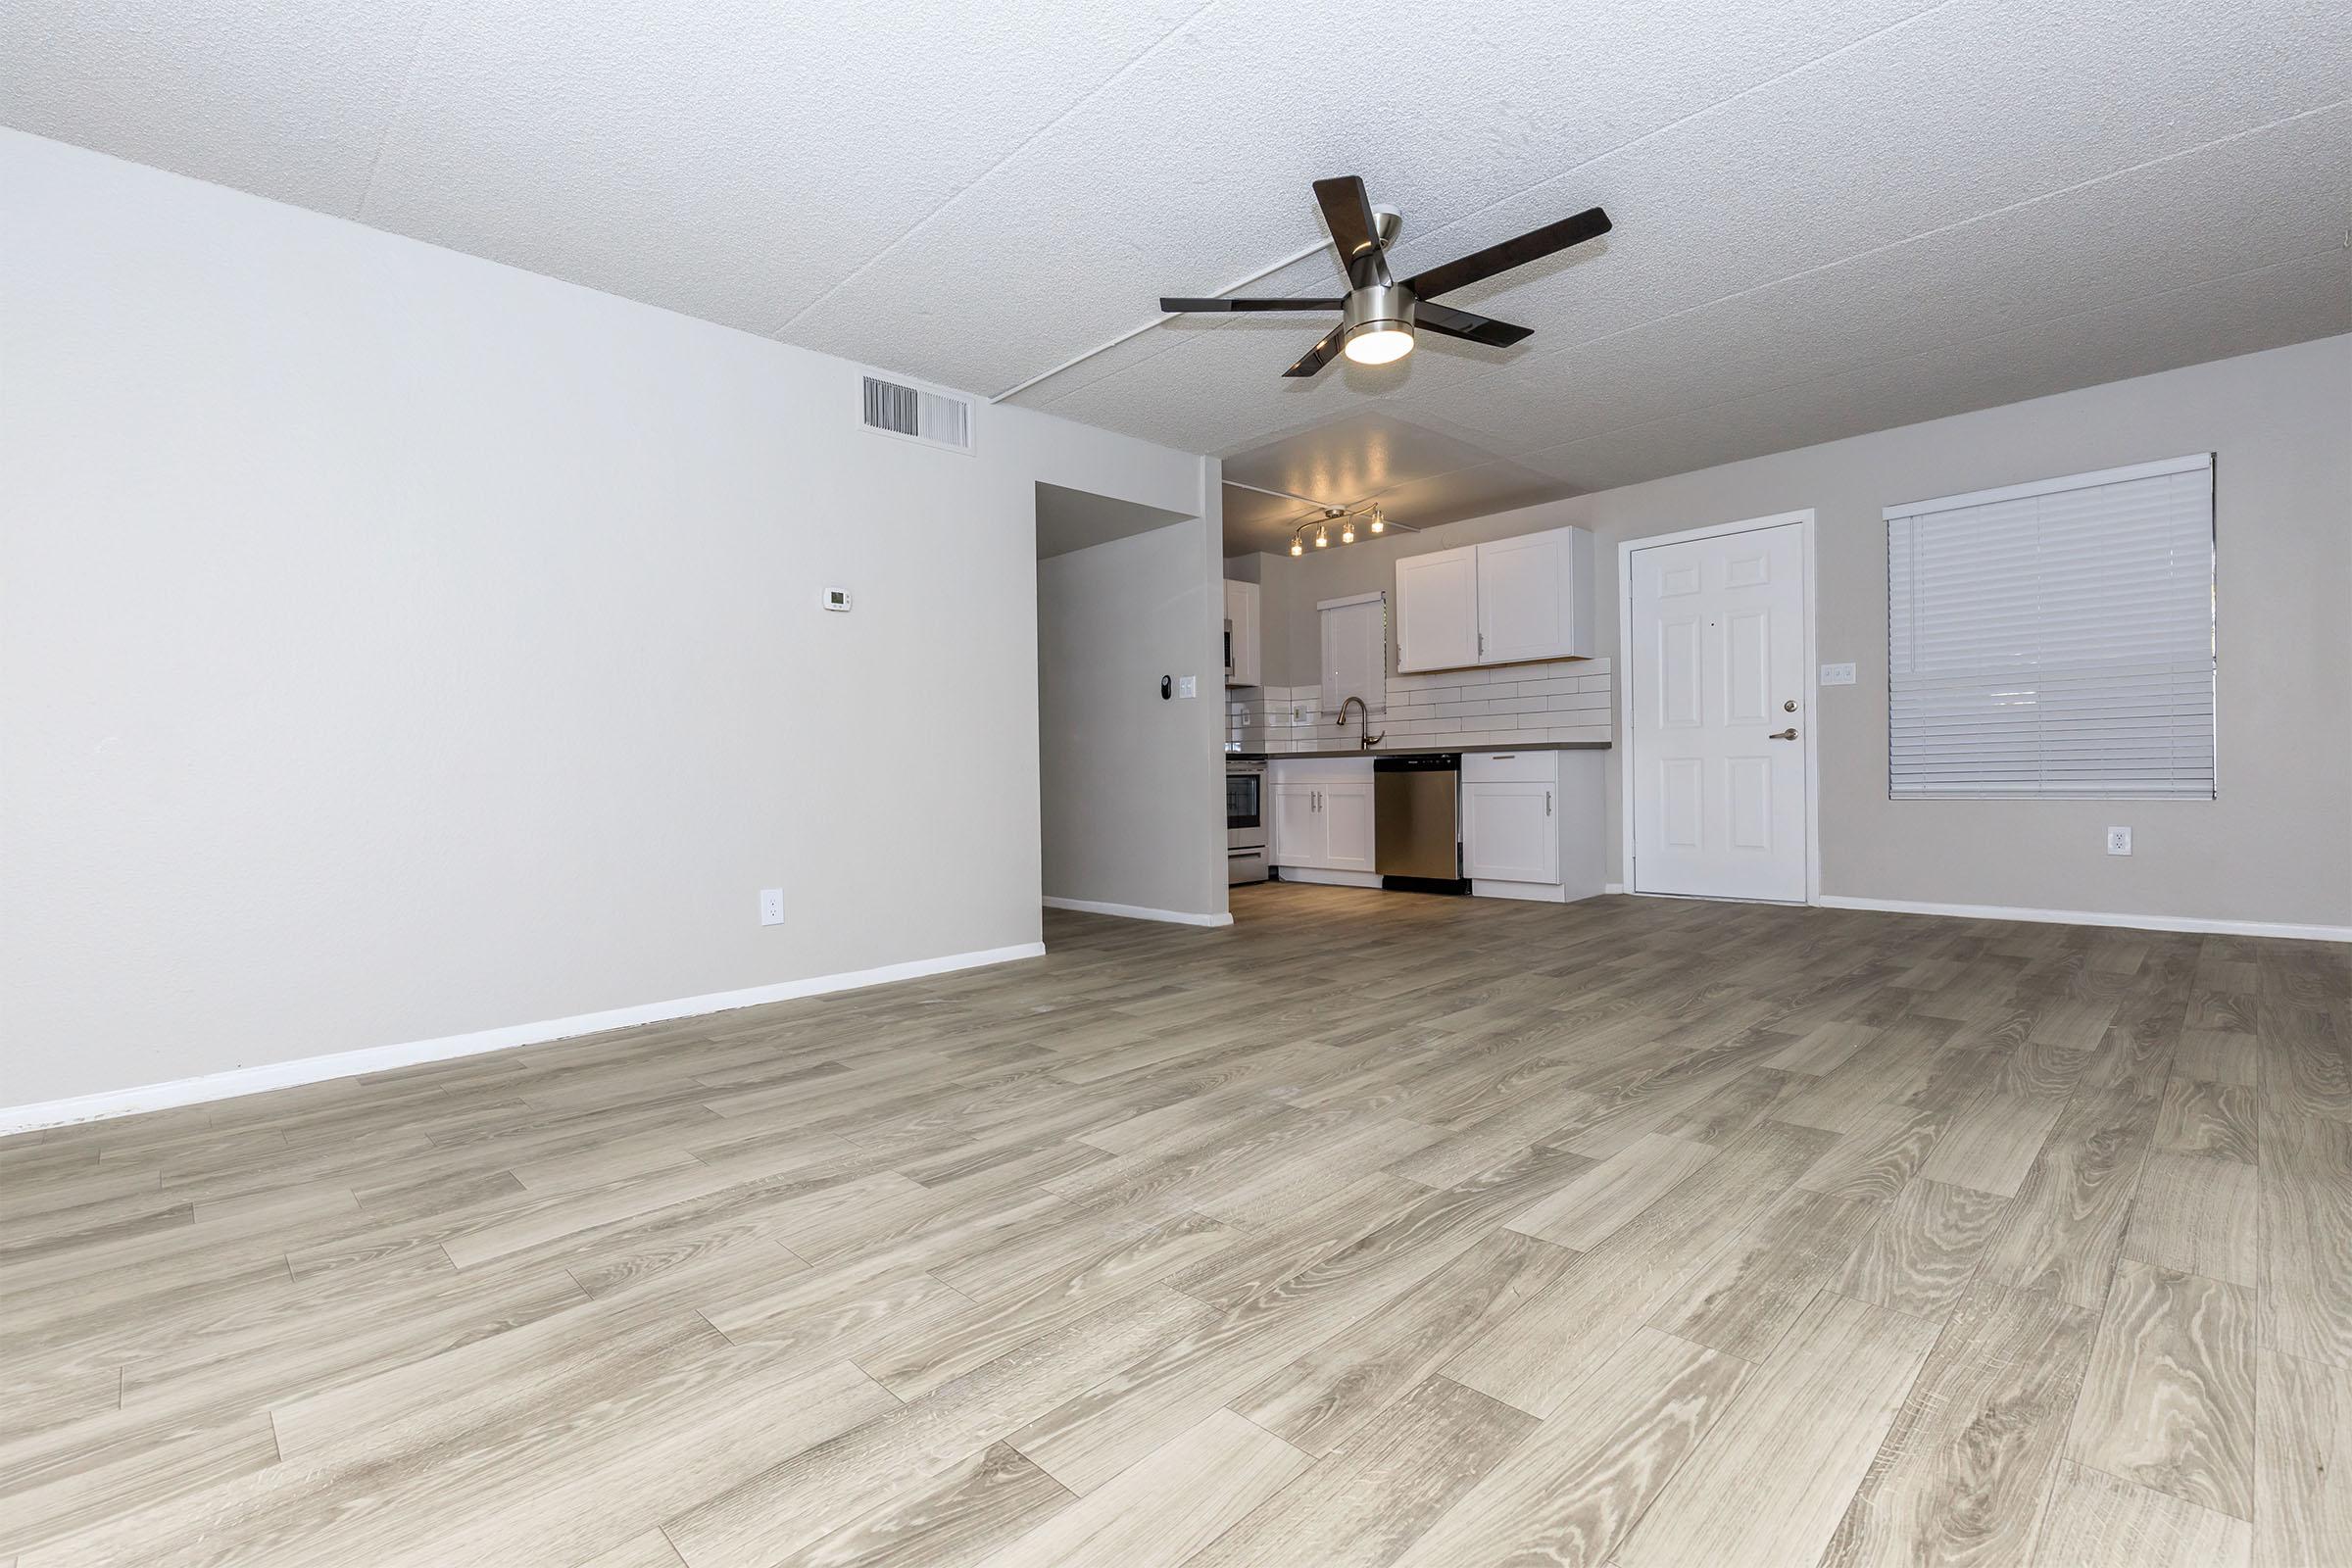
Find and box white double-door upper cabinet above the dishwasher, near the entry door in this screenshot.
[1397,529,1592,672]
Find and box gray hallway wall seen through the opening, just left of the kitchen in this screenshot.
[1037,514,1225,919]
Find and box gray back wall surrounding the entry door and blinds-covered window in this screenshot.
[1260,336,2352,926]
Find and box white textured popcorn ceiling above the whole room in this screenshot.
[0,0,2352,548]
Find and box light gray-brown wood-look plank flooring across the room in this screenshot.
[0,884,2352,1568]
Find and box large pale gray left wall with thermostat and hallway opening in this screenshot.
[0,131,1223,1107]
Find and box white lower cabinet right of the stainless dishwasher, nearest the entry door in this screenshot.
[1463,753,1606,903]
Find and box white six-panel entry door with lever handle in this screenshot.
[1625,522,1813,903]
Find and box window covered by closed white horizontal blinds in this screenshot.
[1886,454,2213,800]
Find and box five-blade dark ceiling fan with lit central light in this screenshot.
[1159,174,1609,376]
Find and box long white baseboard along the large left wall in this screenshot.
[0,943,1045,1136]
